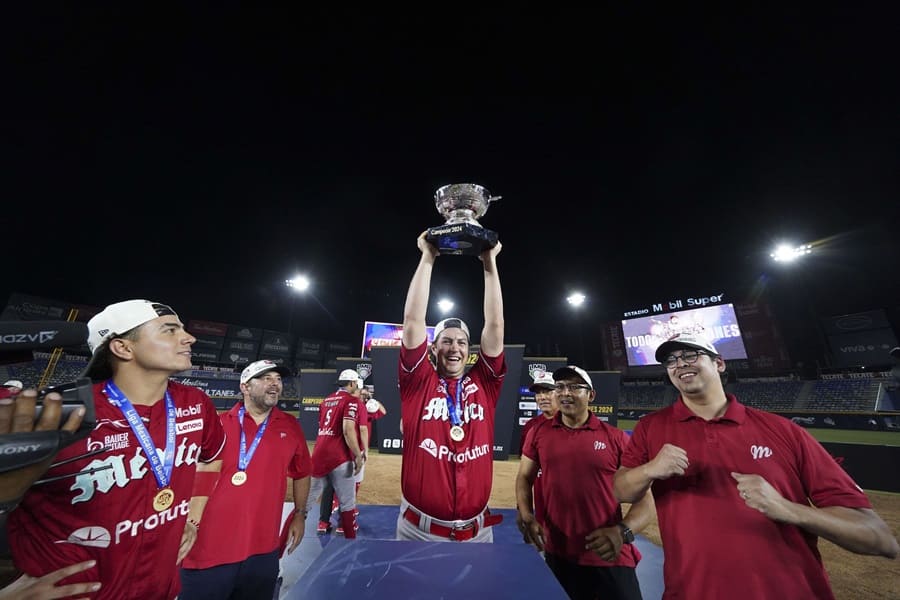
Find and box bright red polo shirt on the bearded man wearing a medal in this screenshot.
[182,403,312,569]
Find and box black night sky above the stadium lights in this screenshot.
[0,3,900,368]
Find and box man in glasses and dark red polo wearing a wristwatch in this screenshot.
[516,365,653,600]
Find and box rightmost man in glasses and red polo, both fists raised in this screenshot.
[615,334,900,600]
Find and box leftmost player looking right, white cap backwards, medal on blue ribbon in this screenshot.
[8,300,225,599]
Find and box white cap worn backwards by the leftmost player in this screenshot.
[82,300,178,380]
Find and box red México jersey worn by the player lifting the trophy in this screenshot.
[400,342,506,521]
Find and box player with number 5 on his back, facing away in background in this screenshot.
[307,369,365,539]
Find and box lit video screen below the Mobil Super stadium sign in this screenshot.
[622,304,747,367]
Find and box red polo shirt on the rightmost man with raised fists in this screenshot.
[622,394,871,600]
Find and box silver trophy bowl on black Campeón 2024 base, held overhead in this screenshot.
[425,183,502,256]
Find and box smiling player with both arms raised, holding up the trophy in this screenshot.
[397,232,506,542]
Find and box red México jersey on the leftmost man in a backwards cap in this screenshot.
[8,382,225,600]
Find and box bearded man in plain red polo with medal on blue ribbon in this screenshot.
[178,360,312,600]
